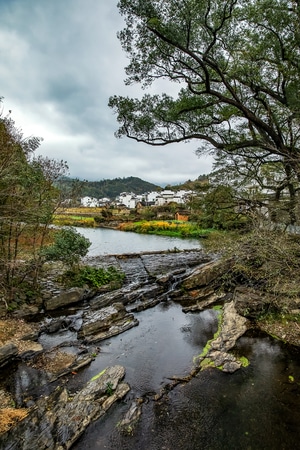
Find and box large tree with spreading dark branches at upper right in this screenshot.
[109,0,300,222]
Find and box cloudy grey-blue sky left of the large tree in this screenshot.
[0,0,211,186]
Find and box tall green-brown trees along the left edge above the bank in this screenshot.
[0,104,67,303]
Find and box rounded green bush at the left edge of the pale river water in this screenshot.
[41,227,91,267]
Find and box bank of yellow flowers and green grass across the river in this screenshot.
[118,220,213,238]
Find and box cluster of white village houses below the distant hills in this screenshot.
[81,189,196,209]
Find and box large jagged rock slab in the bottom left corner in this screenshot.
[0,366,130,450]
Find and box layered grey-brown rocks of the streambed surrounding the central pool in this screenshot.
[0,251,296,450]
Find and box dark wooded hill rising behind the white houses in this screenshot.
[59,177,162,199]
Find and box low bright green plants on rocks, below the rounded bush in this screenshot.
[62,266,125,289]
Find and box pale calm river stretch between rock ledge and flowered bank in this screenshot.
[76,228,201,256]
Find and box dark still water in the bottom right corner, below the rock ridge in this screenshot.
[74,322,300,450]
